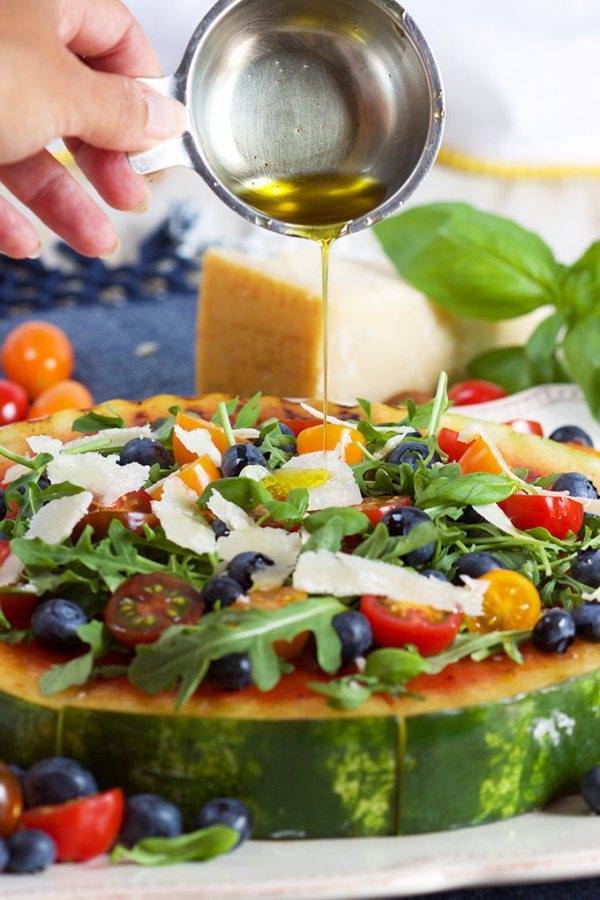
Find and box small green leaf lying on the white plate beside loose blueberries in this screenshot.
[110,825,240,866]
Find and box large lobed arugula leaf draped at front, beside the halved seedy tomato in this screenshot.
[129,597,346,708]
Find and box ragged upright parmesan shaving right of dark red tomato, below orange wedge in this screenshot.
[152,476,217,555]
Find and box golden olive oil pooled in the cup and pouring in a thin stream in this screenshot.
[237,173,387,460]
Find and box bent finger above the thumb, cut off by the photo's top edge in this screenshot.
[59,0,162,78]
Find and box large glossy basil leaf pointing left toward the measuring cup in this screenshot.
[374,203,561,320]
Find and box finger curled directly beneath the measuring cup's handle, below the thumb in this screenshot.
[67,140,150,212]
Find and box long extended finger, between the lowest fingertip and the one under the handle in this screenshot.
[0,150,118,256]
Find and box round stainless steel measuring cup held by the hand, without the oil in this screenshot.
[131,0,444,234]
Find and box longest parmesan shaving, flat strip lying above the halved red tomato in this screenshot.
[293,550,489,616]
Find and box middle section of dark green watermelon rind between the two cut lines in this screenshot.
[62,708,399,838]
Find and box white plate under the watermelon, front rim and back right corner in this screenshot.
[0,385,600,900]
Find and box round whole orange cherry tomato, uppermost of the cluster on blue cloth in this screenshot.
[2,321,74,397]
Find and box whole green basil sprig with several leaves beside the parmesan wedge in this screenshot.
[375,203,600,419]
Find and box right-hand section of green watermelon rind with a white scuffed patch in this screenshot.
[400,671,600,834]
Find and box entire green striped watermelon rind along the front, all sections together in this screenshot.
[0,670,600,838]
